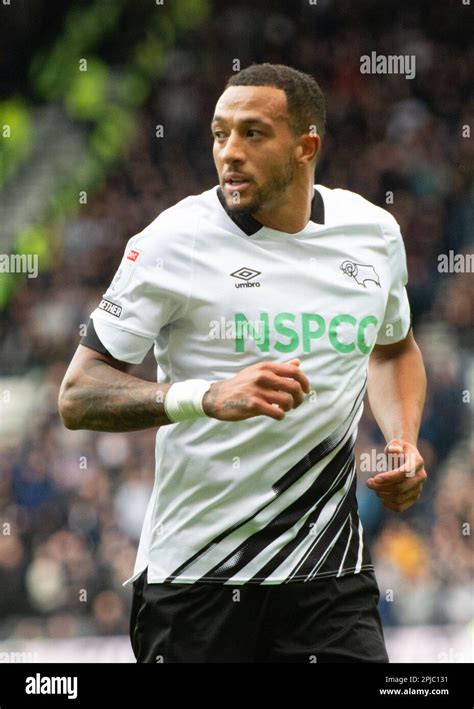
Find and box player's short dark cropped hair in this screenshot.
[226,63,326,140]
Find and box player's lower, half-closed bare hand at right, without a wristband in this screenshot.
[367,438,428,512]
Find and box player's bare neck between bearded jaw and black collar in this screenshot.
[252,181,314,234]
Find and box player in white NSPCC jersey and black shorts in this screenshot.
[59,64,427,663]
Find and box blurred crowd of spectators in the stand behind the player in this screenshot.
[0,2,474,639]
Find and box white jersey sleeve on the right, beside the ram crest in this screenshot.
[376,219,411,345]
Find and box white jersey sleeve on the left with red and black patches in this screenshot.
[90,218,192,364]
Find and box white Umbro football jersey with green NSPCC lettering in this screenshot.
[91,185,410,585]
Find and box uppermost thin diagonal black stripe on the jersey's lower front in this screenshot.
[166,378,367,582]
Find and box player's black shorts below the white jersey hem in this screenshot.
[130,570,389,663]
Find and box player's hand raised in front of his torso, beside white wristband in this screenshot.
[202,359,310,421]
